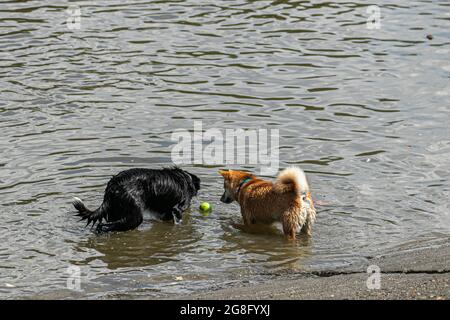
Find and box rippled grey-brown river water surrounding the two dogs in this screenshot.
[0,0,450,298]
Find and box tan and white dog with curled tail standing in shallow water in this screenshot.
[219,167,316,240]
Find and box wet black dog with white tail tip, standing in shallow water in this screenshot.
[73,168,200,232]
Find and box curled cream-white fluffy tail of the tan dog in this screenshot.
[274,167,309,194]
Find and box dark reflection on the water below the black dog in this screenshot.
[75,215,202,269]
